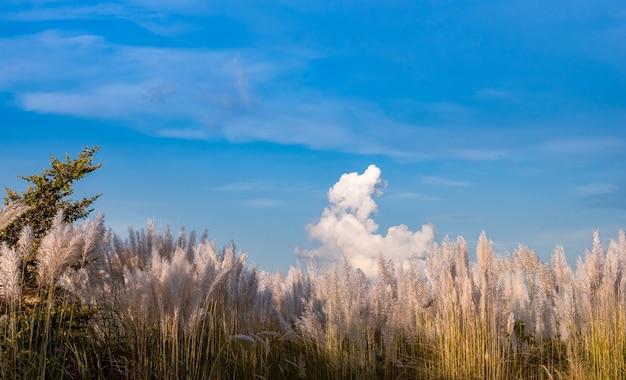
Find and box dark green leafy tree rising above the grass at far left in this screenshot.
[0,146,102,246]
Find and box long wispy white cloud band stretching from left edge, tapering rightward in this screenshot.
[0,23,520,160]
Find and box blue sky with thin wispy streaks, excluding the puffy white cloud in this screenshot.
[0,0,626,270]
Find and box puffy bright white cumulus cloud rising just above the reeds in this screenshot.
[299,165,435,277]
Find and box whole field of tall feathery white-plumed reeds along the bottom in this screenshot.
[0,202,626,379]
